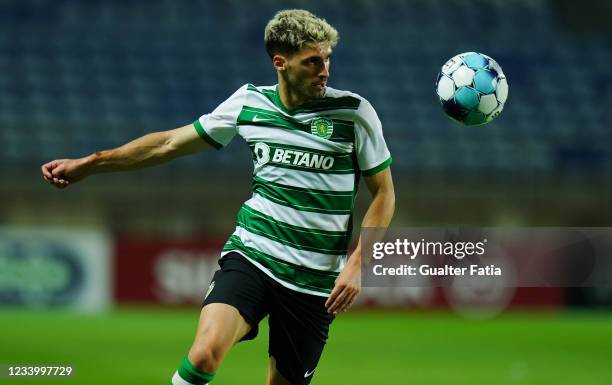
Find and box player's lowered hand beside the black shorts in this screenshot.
[325,258,361,314]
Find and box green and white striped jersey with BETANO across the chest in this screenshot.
[194,84,391,296]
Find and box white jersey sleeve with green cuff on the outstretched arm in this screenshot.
[193,85,247,150]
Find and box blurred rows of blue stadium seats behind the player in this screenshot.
[0,0,612,174]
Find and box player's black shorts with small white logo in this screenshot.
[203,253,334,385]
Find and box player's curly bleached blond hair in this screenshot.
[264,9,339,58]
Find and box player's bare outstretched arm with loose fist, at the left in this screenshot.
[41,124,210,188]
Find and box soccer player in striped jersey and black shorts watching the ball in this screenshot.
[42,10,395,385]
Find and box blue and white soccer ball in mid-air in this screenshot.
[436,52,508,126]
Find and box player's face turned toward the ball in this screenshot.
[281,43,332,101]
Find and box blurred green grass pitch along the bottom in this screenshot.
[0,308,612,385]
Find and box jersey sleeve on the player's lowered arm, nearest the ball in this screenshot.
[355,99,391,176]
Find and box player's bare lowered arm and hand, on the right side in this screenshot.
[325,167,395,314]
